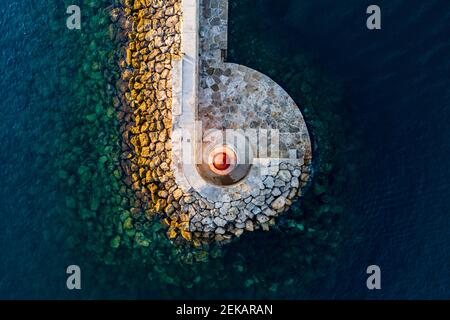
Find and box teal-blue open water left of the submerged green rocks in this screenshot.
[0,0,69,298]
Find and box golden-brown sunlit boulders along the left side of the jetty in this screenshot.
[116,0,191,240]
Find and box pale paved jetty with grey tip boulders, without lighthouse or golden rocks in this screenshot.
[172,0,311,241]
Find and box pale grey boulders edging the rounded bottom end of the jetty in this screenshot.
[182,157,311,241]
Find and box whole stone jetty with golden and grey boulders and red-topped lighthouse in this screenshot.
[120,0,312,242]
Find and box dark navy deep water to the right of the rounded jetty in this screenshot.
[250,0,450,299]
